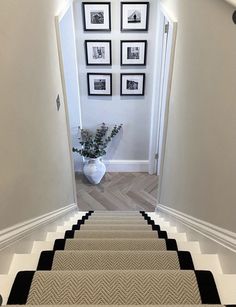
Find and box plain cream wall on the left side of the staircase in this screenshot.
[0,0,74,229]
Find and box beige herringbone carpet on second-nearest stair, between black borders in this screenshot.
[52,251,180,270]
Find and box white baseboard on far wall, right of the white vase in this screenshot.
[104,160,149,173]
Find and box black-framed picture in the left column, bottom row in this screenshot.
[87,73,112,96]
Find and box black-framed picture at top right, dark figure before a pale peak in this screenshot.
[121,2,149,32]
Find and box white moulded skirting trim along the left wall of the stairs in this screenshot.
[0,204,78,250]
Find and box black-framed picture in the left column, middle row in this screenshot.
[85,40,112,65]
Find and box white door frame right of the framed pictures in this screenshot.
[149,3,177,205]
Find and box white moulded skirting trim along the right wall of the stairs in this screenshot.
[157,205,236,253]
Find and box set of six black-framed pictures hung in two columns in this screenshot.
[82,1,150,96]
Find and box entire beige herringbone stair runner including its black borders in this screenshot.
[7,211,223,307]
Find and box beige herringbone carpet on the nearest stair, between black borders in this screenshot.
[27,271,201,305]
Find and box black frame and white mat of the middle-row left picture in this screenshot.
[84,40,112,66]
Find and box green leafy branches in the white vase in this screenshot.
[72,123,122,159]
